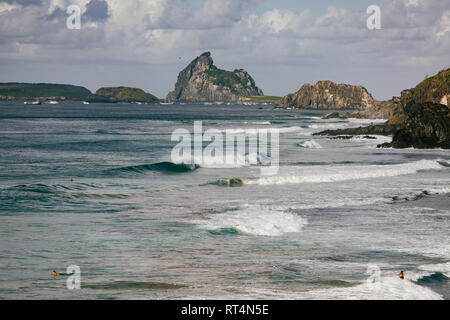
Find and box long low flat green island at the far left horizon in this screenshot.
[0,82,91,100]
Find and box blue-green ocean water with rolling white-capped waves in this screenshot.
[0,102,450,299]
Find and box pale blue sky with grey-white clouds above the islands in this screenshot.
[0,0,450,100]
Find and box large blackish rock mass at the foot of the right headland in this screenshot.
[379,102,450,149]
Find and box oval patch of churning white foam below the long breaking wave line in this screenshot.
[194,205,307,236]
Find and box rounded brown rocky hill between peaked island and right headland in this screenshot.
[277,81,375,110]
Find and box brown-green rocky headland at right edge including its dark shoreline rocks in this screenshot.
[315,69,450,149]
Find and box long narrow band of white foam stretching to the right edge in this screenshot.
[244,160,444,185]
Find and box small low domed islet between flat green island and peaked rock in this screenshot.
[86,87,159,103]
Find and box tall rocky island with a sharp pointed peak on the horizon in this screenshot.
[166,52,263,102]
